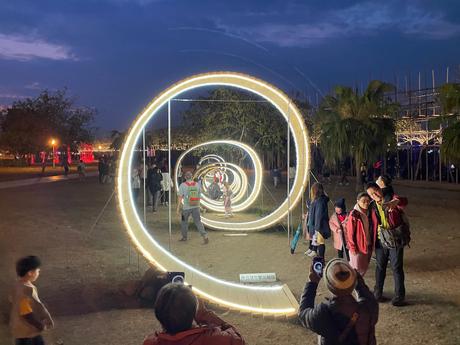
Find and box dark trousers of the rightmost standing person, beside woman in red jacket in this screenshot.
[374,241,406,298]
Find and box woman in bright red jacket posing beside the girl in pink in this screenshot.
[345,192,375,276]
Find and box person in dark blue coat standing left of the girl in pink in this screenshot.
[307,182,331,258]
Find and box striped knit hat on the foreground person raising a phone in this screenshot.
[324,259,356,296]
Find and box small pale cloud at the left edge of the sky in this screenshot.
[0,34,77,61]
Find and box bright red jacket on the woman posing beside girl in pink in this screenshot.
[345,209,376,254]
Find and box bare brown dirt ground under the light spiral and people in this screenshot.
[0,178,460,345]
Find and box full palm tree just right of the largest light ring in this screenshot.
[317,80,397,190]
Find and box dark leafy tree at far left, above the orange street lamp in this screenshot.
[0,89,95,155]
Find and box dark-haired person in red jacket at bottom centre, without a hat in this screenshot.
[143,283,245,345]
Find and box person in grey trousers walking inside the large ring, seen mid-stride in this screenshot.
[177,171,209,244]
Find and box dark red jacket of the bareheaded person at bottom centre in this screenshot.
[143,310,245,345]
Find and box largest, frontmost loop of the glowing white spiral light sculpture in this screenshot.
[117,72,309,316]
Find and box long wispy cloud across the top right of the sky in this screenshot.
[225,2,460,47]
